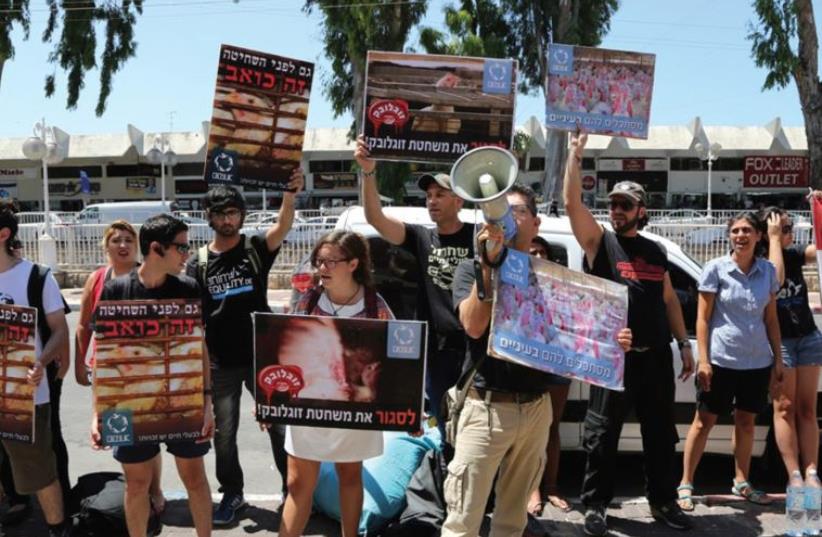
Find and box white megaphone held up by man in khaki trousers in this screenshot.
[451,147,519,242]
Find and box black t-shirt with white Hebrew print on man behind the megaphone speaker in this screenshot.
[402,224,474,350]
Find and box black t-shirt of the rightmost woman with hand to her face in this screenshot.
[776,245,816,338]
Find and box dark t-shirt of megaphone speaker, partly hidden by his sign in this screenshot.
[454,260,555,394]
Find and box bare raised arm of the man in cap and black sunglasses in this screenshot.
[562,133,603,263]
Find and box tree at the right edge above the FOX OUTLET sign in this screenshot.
[748,0,822,189]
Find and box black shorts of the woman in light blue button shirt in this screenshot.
[696,364,771,415]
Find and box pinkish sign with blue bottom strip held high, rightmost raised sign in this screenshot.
[545,44,656,139]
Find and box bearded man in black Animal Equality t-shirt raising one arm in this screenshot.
[186,169,303,526]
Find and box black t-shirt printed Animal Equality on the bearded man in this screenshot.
[186,235,279,369]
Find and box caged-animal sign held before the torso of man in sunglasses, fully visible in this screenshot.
[94,299,204,446]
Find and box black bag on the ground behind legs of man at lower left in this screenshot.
[71,472,162,537]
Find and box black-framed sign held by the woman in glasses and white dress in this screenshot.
[253,313,428,431]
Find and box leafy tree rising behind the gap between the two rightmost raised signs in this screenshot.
[420,0,618,201]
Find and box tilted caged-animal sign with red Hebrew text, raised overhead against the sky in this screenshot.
[205,45,314,190]
